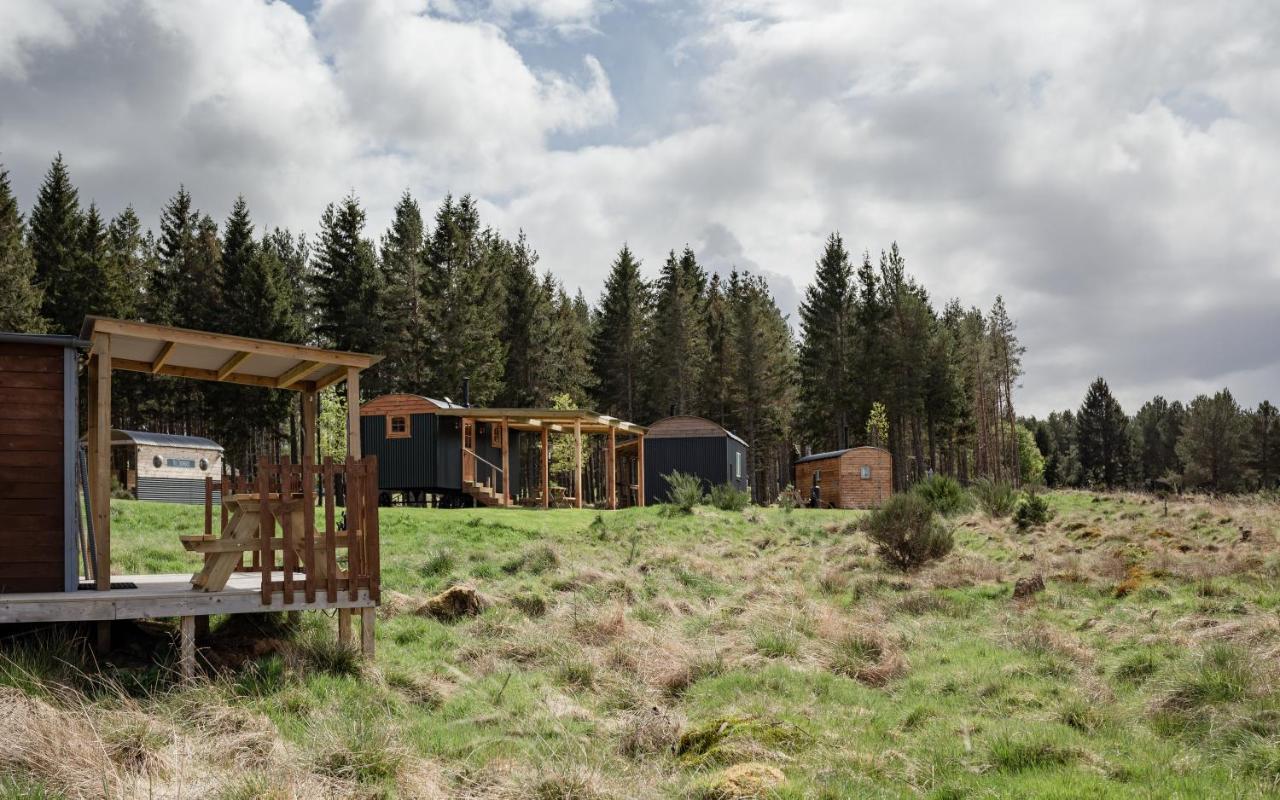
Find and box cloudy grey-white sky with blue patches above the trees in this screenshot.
[0,0,1280,415]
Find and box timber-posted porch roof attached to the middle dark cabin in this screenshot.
[435,408,645,508]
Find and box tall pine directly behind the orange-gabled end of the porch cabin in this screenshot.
[376,191,428,393]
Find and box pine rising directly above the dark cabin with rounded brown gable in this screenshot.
[646,247,710,417]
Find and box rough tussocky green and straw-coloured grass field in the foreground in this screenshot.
[0,493,1280,800]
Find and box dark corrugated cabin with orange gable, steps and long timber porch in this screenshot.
[360,394,645,508]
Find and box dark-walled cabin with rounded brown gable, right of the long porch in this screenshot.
[645,415,750,503]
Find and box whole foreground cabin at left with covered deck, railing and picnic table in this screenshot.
[0,316,381,676]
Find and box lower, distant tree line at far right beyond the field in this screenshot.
[1024,378,1280,492]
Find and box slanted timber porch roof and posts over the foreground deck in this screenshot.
[81,316,381,655]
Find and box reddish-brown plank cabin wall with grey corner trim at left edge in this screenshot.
[0,333,83,593]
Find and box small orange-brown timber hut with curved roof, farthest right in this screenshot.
[795,447,893,508]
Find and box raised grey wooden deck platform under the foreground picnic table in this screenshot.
[0,572,378,623]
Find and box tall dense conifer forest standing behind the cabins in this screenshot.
[0,155,1034,499]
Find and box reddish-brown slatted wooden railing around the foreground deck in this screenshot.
[205,456,381,605]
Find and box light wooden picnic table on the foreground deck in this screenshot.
[182,493,347,591]
